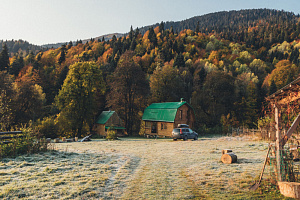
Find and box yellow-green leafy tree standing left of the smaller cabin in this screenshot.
[56,62,104,137]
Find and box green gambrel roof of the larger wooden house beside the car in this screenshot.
[142,101,190,122]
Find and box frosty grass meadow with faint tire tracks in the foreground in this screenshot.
[0,137,290,199]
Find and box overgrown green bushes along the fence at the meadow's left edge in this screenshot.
[0,126,48,159]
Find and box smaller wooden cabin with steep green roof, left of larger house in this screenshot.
[94,111,127,136]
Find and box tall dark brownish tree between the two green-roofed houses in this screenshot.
[107,51,149,135]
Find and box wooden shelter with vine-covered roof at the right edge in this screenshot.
[266,77,300,181]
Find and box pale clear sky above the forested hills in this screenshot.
[0,0,300,45]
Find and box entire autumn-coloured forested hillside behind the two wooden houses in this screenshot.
[0,9,300,138]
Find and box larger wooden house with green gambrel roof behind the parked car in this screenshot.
[142,100,195,137]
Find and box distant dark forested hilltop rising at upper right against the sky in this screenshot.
[141,9,300,48]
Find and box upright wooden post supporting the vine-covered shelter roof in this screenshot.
[275,106,282,181]
